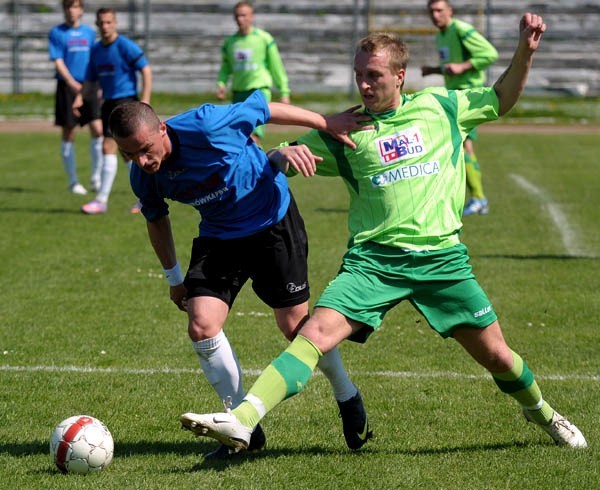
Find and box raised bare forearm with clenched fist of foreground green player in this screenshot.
[494,12,546,116]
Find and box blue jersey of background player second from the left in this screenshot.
[85,35,148,100]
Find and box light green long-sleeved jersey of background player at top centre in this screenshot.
[217,27,290,96]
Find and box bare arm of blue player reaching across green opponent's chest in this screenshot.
[269,102,373,150]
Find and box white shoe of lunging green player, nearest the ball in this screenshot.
[179,410,252,449]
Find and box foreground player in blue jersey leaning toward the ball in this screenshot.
[109,91,369,457]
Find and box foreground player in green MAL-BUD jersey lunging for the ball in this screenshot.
[181,13,587,447]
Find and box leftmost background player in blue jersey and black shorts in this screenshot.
[48,0,102,195]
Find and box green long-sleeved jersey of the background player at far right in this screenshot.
[435,19,498,89]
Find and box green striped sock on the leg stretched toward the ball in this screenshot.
[232,335,323,427]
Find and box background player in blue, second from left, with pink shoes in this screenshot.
[73,8,152,214]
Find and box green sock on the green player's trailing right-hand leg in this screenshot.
[492,351,554,424]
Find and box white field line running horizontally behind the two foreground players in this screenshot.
[0,364,600,381]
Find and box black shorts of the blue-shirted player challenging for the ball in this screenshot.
[184,193,310,308]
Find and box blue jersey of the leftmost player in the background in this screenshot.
[48,24,96,82]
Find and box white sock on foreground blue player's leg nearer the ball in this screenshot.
[192,330,244,408]
